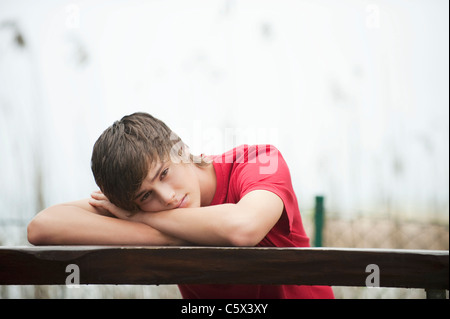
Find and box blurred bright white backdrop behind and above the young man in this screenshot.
[0,0,449,231]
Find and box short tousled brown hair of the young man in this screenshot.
[91,113,187,211]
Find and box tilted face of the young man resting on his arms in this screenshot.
[135,161,200,212]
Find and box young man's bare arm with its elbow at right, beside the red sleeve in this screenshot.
[97,190,284,246]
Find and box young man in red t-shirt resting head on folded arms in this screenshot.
[28,113,333,298]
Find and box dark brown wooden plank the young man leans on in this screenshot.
[0,246,449,289]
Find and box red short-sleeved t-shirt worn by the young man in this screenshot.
[179,145,334,299]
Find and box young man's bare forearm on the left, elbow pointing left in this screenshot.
[28,205,188,246]
